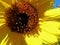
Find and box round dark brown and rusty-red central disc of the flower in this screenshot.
[5,2,38,33]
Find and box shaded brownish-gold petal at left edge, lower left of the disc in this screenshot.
[0,25,9,43]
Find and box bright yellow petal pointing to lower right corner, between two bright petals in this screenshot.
[40,30,57,44]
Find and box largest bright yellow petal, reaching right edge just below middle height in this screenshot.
[40,21,60,35]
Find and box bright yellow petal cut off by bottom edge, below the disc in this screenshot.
[25,36,42,45]
